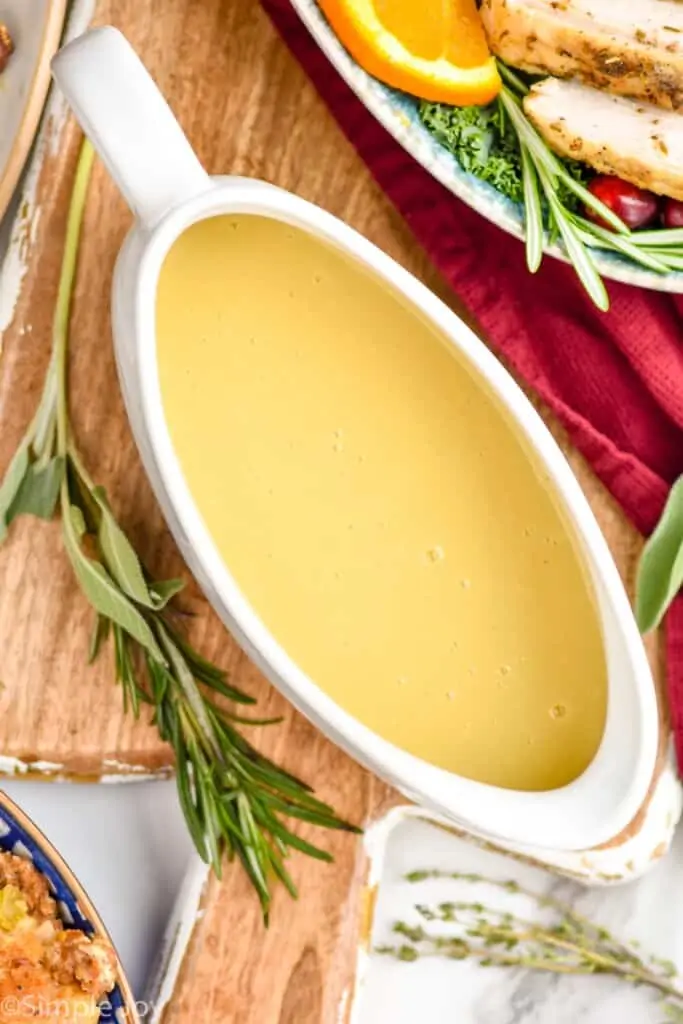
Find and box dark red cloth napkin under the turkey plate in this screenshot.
[261,0,683,766]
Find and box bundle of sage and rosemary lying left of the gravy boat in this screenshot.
[0,141,358,922]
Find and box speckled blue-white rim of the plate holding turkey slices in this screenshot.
[292,0,683,292]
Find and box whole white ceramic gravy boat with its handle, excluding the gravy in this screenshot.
[53,28,658,850]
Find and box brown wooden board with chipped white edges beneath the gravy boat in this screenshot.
[0,0,666,1024]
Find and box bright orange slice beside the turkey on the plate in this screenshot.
[318,0,501,106]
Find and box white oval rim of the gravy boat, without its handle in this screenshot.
[125,179,658,850]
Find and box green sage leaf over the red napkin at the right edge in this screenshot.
[636,476,683,633]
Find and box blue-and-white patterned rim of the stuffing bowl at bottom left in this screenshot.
[0,791,140,1024]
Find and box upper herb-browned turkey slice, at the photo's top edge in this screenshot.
[481,0,683,110]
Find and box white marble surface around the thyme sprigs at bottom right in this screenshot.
[352,819,683,1024]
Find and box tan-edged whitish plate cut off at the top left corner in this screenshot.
[0,0,67,223]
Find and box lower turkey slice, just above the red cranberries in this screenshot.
[524,78,683,200]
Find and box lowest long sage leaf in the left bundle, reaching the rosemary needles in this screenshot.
[62,505,166,665]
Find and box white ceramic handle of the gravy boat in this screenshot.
[52,26,211,228]
